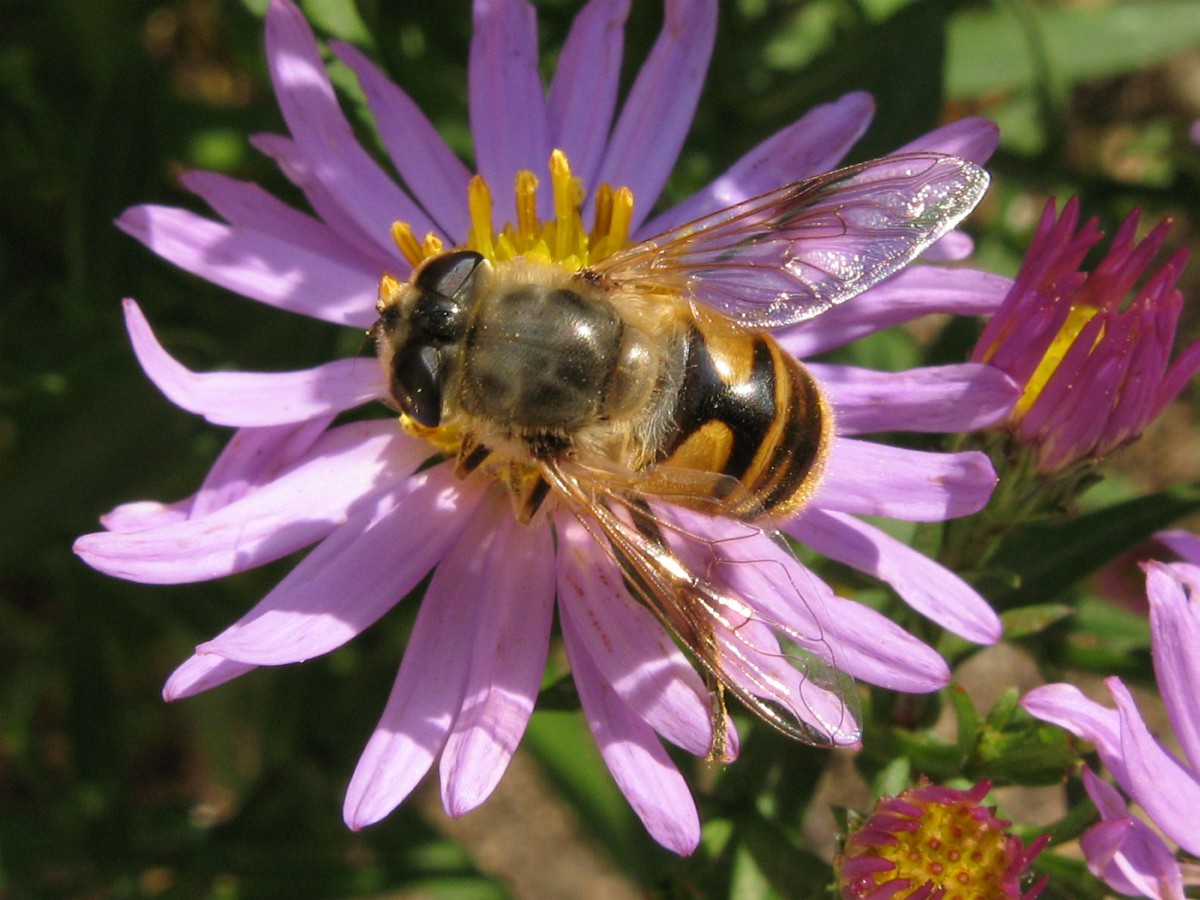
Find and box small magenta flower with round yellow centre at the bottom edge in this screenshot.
[835,780,1050,900]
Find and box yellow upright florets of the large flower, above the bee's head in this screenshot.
[391,150,634,272]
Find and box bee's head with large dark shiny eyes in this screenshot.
[372,250,484,428]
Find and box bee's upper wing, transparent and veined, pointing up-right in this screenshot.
[593,152,988,329]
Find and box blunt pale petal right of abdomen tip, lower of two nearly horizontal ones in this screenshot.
[811,438,996,522]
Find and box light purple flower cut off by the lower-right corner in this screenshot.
[1021,562,1200,900]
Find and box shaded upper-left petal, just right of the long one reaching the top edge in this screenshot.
[331,41,470,241]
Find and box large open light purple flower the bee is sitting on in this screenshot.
[76,0,1015,853]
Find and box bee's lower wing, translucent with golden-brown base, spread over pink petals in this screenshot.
[544,462,859,758]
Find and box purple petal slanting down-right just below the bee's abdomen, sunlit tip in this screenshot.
[784,508,1002,643]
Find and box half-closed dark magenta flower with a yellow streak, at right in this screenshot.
[972,198,1200,473]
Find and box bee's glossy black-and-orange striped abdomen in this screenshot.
[660,326,833,521]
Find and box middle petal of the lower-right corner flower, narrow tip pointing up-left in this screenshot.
[1105,678,1200,854]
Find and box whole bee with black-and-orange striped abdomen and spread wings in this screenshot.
[373,152,988,757]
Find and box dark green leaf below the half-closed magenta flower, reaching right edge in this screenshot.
[990,487,1200,608]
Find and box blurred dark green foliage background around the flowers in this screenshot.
[7,0,1200,898]
